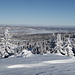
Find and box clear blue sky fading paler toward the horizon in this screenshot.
[0,0,75,26]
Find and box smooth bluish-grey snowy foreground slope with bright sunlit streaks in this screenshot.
[0,54,75,75]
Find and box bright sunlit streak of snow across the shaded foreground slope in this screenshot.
[7,58,75,68]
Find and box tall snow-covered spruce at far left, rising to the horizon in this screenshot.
[0,27,14,58]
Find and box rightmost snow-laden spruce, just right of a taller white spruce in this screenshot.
[63,38,74,56]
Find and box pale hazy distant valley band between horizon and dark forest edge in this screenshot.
[0,26,75,34]
